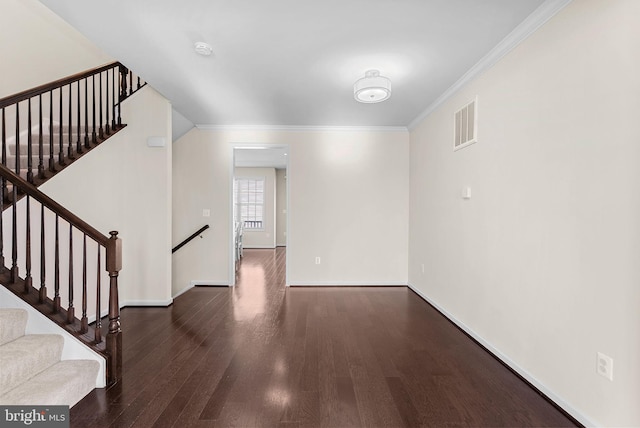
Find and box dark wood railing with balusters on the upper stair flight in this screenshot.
[0,62,146,191]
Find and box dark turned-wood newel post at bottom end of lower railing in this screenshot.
[106,231,122,384]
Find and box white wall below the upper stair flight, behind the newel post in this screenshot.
[40,86,172,305]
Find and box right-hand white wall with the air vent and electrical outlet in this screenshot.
[409,0,640,426]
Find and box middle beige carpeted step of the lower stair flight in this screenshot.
[0,334,64,394]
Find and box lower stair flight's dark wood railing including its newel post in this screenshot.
[0,165,122,384]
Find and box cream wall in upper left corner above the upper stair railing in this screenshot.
[0,0,113,98]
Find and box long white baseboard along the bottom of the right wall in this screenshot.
[408,284,604,427]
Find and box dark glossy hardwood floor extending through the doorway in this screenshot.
[71,248,575,427]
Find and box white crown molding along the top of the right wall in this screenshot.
[407,0,572,131]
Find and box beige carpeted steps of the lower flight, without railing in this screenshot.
[0,309,99,406]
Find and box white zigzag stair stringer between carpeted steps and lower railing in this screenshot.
[0,286,107,388]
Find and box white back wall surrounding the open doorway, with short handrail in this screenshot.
[173,129,409,293]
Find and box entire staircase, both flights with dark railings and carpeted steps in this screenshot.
[0,62,145,406]
